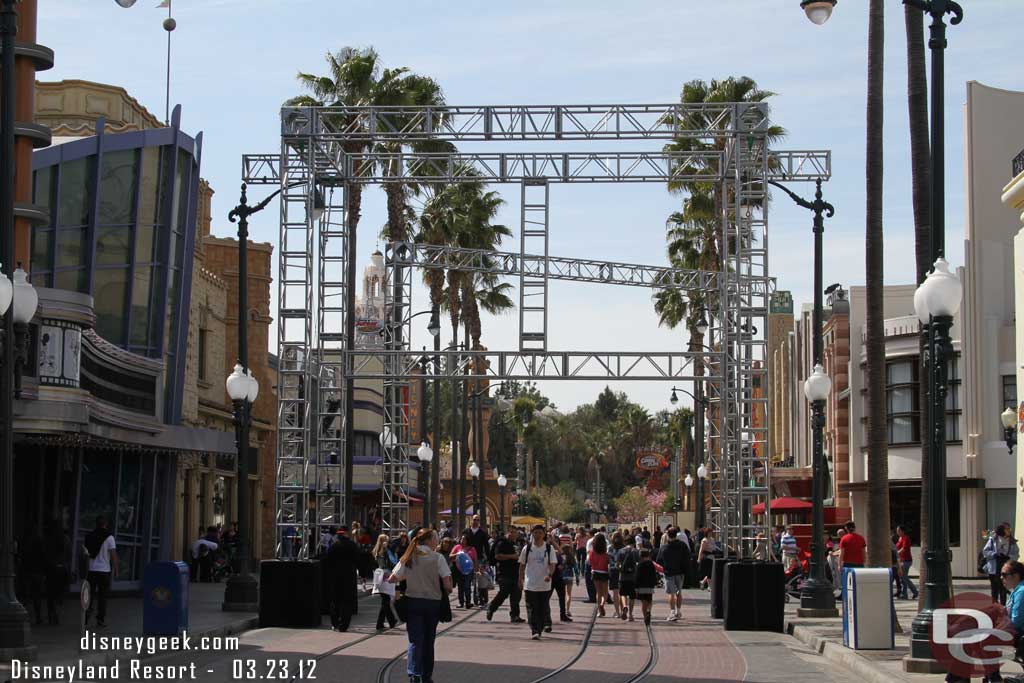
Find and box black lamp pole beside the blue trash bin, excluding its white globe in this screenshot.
[222,183,258,611]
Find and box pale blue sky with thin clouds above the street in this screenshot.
[39,0,1024,411]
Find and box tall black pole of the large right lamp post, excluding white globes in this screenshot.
[904,0,964,660]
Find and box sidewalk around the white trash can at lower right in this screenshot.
[785,580,1021,683]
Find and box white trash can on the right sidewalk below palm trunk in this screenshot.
[843,567,896,650]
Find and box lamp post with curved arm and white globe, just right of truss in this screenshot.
[765,176,837,616]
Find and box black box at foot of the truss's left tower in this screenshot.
[259,560,321,629]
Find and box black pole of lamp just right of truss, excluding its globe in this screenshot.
[798,178,836,615]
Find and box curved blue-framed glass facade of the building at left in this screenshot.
[30,108,203,424]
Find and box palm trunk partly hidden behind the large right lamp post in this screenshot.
[903,4,932,608]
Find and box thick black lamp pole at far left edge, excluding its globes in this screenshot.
[0,0,36,659]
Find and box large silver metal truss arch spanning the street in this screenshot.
[249,102,830,557]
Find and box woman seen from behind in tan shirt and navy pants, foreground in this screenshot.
[388,528,452,683]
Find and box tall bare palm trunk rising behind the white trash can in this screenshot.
[864,0,891,567]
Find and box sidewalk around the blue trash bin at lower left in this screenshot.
[0,583,368,681]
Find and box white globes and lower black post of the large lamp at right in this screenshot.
[904,257,962,673]
